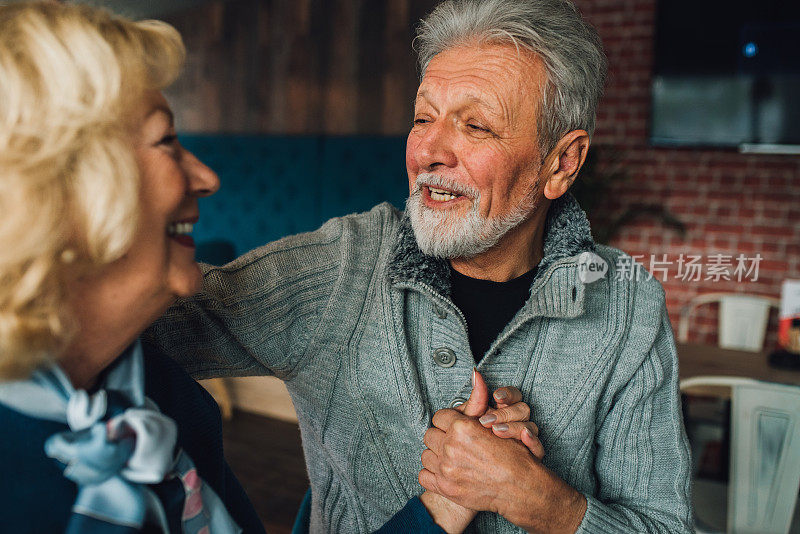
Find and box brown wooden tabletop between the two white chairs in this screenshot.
[677,343,800,397]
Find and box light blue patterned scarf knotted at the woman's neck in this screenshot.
[0,341,241,534]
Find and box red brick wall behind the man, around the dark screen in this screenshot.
[576,0,800,348]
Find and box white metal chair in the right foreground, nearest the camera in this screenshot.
[681,376,800,534]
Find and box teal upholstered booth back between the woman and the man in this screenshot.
[181,135,408,263]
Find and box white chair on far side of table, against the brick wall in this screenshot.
[678,293,780,352]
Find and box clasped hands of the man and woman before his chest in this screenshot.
[419,371,586,532]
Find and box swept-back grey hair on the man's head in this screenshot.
[414,0,607,157]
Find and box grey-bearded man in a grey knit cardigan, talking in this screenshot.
[152,0,691,533]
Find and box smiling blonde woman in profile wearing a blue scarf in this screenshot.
[0,2,263,534]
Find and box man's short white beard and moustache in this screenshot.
[406,173,537,259]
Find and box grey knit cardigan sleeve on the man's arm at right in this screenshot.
[578,307,693,534]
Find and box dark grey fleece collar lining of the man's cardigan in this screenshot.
[388,193,595,296]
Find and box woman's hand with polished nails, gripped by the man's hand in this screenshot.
[420,370,544,534]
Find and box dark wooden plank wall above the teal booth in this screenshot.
[162,0,436,135]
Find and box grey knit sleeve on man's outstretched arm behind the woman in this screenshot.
[143,214,344,379]
